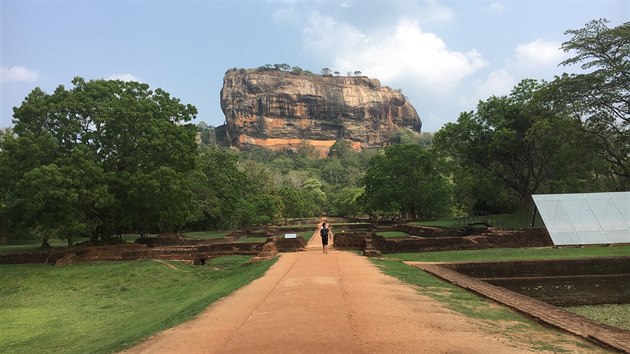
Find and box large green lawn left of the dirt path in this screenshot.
[0,256,275,353]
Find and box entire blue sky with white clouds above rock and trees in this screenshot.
[0,0,630,132]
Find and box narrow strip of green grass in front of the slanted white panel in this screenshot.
[384,245,630,262]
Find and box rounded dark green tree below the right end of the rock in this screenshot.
[362,144,452,218]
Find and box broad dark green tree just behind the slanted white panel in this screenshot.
[434,80,590,206]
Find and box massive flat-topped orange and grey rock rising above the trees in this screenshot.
[221,69,422,155]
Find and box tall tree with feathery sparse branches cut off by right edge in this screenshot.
[553,19,630,190]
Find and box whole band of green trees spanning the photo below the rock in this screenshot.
[0,20,630,243]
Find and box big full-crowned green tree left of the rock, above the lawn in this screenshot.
[6,77,197,239]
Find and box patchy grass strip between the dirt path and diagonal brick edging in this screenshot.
[370,258,602,353]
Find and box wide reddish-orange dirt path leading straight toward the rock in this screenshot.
[127,228,608,354]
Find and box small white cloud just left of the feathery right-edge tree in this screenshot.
[511,39,566,69]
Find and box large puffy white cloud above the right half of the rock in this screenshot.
[304,14,487,96]
